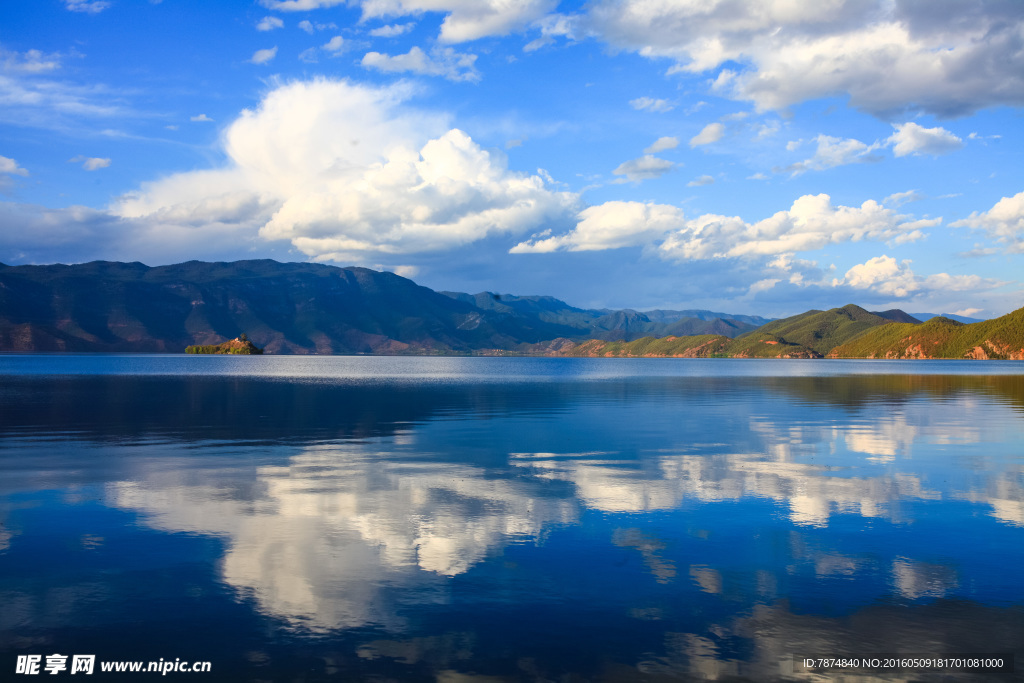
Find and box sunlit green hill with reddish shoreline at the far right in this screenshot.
[828,308,1024,360]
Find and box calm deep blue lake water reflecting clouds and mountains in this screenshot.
[0,355,1024,683]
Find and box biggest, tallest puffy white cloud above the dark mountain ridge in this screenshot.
[112,79,578,262]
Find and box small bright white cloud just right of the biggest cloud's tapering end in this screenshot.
[509,202,683,254]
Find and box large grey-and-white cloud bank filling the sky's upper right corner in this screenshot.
[587,0,1024,117]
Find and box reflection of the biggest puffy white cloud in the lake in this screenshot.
[108,444,578,630]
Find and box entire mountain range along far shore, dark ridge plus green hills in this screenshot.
[0,260,1011,357]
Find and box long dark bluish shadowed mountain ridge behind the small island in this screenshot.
[0,260,770,353]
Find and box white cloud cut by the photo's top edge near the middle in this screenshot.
[360,0,558,43]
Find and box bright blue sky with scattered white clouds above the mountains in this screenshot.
[0,0,1024,317]
